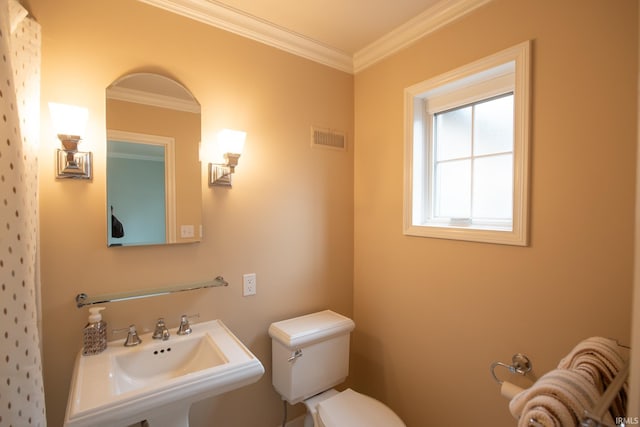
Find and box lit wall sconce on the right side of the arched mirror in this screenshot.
[200,129,247,187]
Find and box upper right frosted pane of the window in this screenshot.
[474,95,513,156]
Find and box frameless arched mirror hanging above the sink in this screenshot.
[106,73,202,246]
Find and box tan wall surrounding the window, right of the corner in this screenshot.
[352,0,638,427]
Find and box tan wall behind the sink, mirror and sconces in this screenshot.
[33,0,353,427]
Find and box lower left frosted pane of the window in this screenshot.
[434,160,471,218]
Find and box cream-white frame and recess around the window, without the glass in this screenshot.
[403,41,531,246]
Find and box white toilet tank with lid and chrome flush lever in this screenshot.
[269,310,355,404]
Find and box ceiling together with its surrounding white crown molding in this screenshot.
[139,0,491,73]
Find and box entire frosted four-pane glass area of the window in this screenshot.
[432,94,513,223]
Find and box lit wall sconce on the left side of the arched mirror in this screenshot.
[49,102,92,179]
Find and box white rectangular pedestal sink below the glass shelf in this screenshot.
[64,320,264,427]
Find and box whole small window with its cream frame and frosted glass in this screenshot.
[404,42,529,245]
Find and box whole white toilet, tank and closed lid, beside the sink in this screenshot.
[269,310,405,427]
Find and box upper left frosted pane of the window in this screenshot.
[435,107,471,161]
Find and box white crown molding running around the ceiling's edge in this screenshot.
[138,0,492,74]
